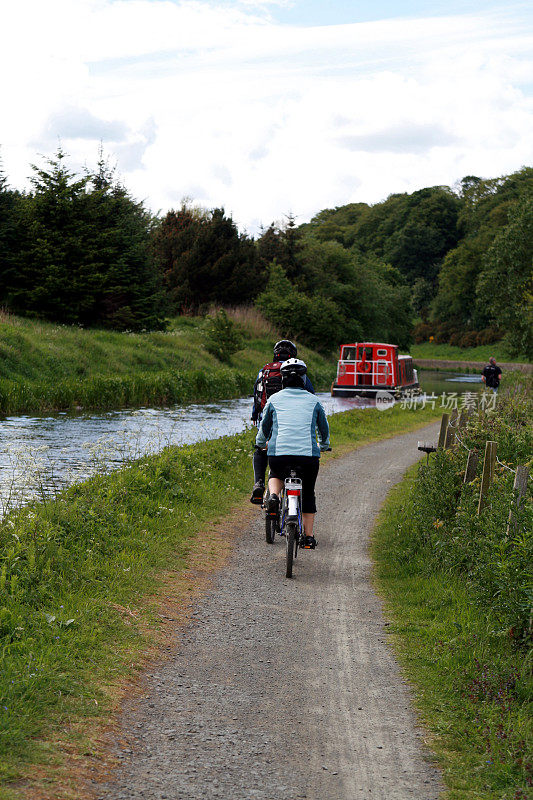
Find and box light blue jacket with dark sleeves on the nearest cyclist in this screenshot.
[255,388,329,456]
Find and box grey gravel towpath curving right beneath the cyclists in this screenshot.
[96,425,442,800]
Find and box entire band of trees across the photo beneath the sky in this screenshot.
[0,149,533,352]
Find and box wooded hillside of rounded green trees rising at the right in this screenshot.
[303,167,533,358]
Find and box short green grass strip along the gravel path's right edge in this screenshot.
[372,467,533,800]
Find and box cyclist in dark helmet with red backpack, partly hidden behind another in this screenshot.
[250,339,315,505]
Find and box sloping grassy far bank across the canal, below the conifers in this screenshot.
[0,314,335,414]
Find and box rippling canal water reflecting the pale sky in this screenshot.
[0,371,482,513]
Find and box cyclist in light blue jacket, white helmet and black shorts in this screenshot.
[255,358,329,547]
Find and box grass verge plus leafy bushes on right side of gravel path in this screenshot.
[373,382,533,800]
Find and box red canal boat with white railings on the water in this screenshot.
[331,342,419,397]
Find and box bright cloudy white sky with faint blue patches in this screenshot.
[0,0,533,233]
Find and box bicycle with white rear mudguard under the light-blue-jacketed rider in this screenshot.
[264,470,305,578]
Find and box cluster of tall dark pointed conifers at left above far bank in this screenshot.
[10,148,164,330]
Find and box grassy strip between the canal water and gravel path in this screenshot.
[0,400,435,798]
